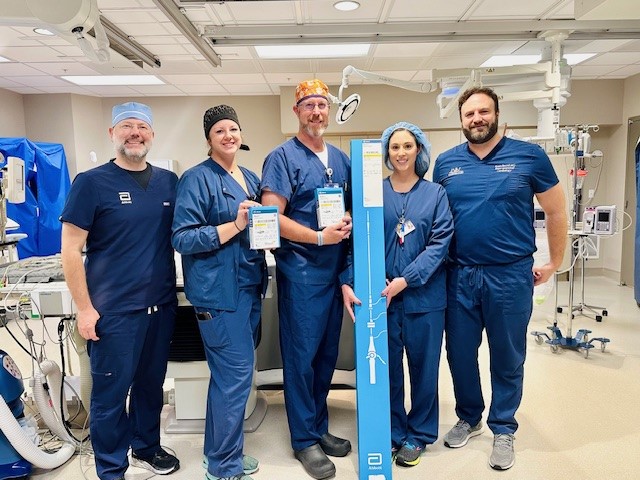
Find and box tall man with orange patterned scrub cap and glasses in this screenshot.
[262,79,352,479]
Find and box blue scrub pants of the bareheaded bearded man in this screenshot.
[445,257,533,435]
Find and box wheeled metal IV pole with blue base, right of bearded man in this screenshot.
[531,126,610,358]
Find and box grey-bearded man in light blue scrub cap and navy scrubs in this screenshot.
[60,102,180,480]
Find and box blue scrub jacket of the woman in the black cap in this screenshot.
[172,158,266,311]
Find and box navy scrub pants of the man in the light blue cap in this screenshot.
[87,302,177,480]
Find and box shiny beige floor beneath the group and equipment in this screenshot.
[0,277,640,480]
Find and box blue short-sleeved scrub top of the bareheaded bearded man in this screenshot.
[433,137,558,265]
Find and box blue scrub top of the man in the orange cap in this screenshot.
[261,137,351,285]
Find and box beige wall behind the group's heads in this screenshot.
[0,75,640,272]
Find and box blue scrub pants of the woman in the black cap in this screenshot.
[195,286,261,478]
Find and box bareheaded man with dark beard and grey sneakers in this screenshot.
[433,88,567,470]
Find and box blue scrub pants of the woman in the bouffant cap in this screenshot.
[387,299,444,448]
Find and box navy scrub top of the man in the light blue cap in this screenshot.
[60,161,178,315]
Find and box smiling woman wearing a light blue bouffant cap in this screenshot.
[342,122,453,467]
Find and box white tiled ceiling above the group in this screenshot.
[0,0,640,97]
